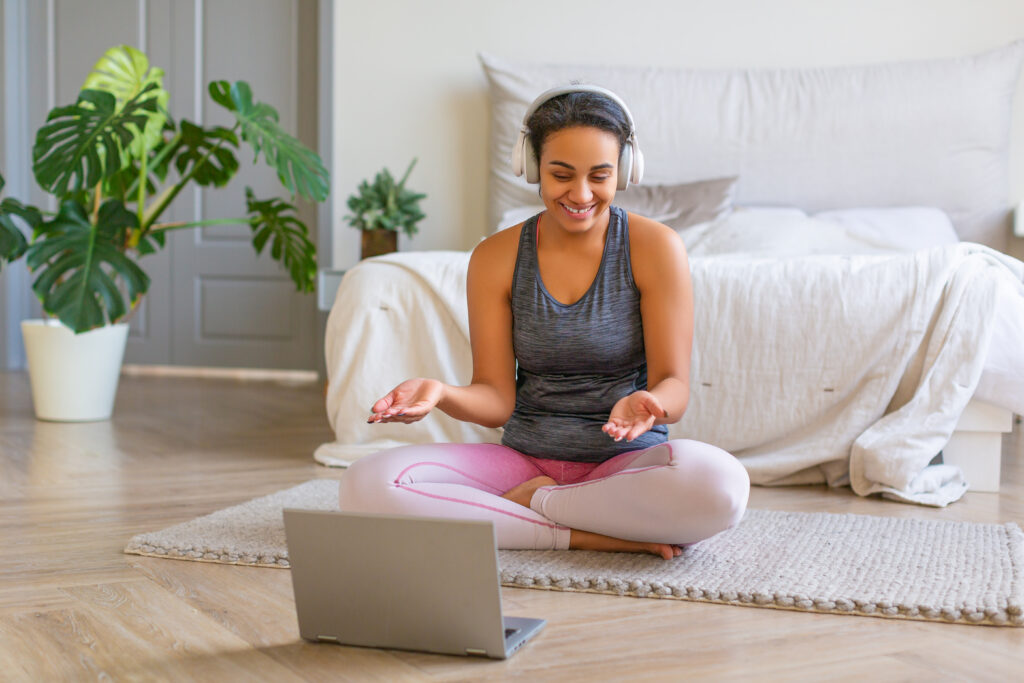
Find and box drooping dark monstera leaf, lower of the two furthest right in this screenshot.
[246,187,316,292]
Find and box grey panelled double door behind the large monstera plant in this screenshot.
[3,0,318,370]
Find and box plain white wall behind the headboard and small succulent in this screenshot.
[332,0,1024,268]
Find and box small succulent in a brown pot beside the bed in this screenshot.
[345,159,426,258]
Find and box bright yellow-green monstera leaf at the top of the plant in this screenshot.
[82,45,171,159]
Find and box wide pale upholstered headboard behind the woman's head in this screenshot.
[480,46,1024,249]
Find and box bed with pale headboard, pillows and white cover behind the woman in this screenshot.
[315,41,1024,506]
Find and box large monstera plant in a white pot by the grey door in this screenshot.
[0,45,329,421]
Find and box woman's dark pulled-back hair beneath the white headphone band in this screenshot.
[526,91,630,161]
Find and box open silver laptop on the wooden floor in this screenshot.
[285,509,545,659]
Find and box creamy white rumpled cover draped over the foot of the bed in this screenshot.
[315,243,1024,506]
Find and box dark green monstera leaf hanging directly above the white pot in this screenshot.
[27,200,150,334]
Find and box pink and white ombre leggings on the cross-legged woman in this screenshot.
[339,439,750,550]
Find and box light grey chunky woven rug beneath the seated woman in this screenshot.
[125,479,1024,626]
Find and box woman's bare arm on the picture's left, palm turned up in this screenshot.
[370,227,519,427]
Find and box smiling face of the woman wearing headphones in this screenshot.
[540,126,618,232]
